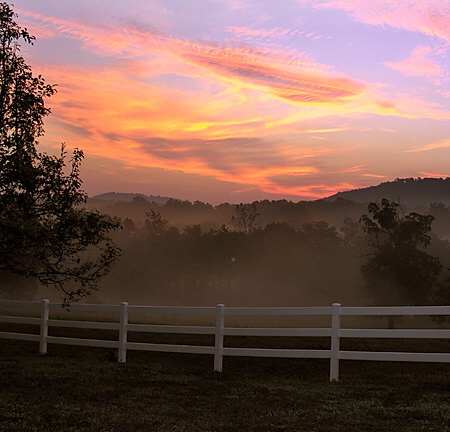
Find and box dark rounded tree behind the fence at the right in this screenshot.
[360,199,442,304]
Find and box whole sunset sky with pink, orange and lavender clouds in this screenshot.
[10,0,450,205]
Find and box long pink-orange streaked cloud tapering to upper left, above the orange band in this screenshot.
[25,13,364,104]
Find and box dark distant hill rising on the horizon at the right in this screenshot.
[325,177,450,206]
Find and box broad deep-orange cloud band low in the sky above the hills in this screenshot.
[37,56,444,199]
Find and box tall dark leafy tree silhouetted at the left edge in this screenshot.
[0,3,120,304]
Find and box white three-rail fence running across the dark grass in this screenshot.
[0,300,450,381]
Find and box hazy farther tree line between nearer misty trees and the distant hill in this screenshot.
[86,194,450,239]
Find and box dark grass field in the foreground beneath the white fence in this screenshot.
[0,328,450,432]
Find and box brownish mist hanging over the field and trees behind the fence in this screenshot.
[14,179,450,306]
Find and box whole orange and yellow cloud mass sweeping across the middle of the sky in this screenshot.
[20,5,447,202]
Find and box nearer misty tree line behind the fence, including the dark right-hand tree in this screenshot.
[85,200,450,305]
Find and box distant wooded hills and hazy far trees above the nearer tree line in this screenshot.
[87,178,450,238]
